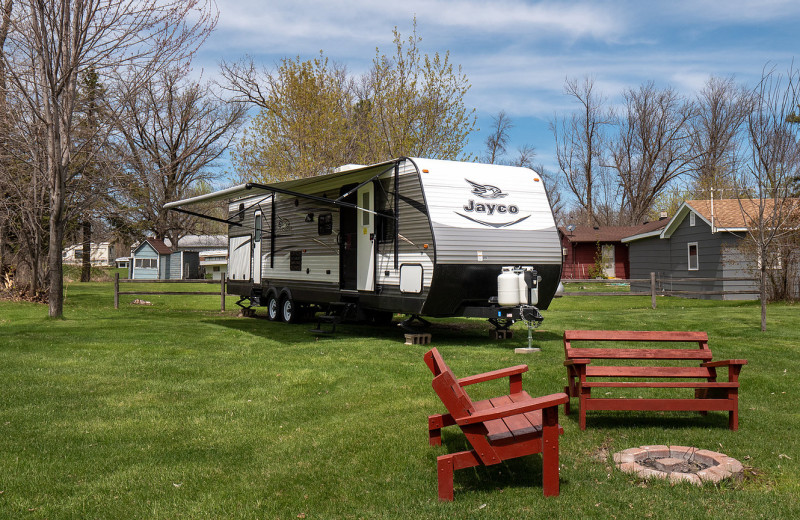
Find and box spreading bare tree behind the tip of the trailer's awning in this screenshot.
[114,68,246,247]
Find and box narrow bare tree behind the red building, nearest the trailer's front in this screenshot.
[550,76,612,226]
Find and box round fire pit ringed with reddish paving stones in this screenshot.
[614,445,743,486]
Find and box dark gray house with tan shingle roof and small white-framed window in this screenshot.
[622,199,758,300]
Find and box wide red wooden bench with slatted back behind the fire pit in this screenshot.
[564,330,747,430]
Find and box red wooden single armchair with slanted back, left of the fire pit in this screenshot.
[425,348,568,501]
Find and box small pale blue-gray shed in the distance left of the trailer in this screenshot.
[128,238,200,280]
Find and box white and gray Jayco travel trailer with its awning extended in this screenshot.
[165,158,561,328]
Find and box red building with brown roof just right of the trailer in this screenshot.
[558,219,669,279]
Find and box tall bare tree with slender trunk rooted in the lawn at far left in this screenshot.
[2,0,216,317]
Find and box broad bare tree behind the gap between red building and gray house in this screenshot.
[610,82,694,224]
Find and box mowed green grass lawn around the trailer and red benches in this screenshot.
[0,283,800,519]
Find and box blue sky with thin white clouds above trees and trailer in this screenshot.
[194,0,800,179]
